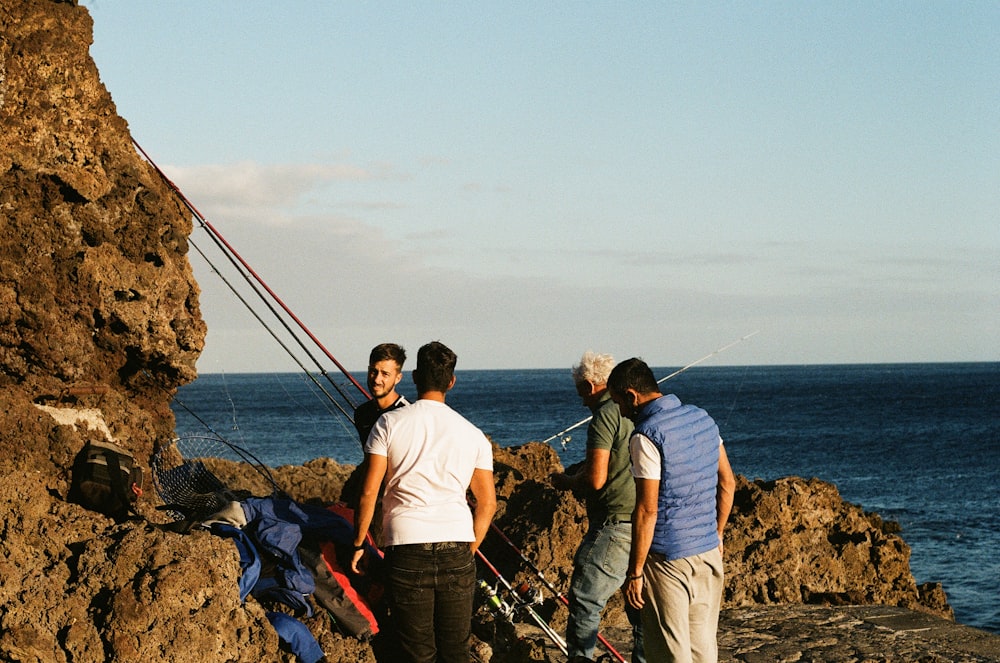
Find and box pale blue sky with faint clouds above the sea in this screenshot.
[81,0,1000,373]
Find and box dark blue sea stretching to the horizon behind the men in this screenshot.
[173,363,1000,633]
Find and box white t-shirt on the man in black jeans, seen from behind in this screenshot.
[365,399,493,546]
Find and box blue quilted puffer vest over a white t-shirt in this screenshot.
[635,394,719,560]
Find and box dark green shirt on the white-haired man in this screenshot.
[586,392,635,526]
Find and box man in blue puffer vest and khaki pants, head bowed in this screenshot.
[608,358,736,663]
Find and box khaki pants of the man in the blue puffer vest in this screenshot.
[642,548,723,663]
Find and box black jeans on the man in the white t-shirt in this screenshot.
[385,542,476,663]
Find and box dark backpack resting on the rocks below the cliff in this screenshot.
[69,442,142,520]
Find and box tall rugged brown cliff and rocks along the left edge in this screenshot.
[0,0,277,662]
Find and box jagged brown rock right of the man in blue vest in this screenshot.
[725,477,954,619]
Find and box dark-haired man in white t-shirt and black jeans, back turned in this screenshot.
[351,341,496,663]
